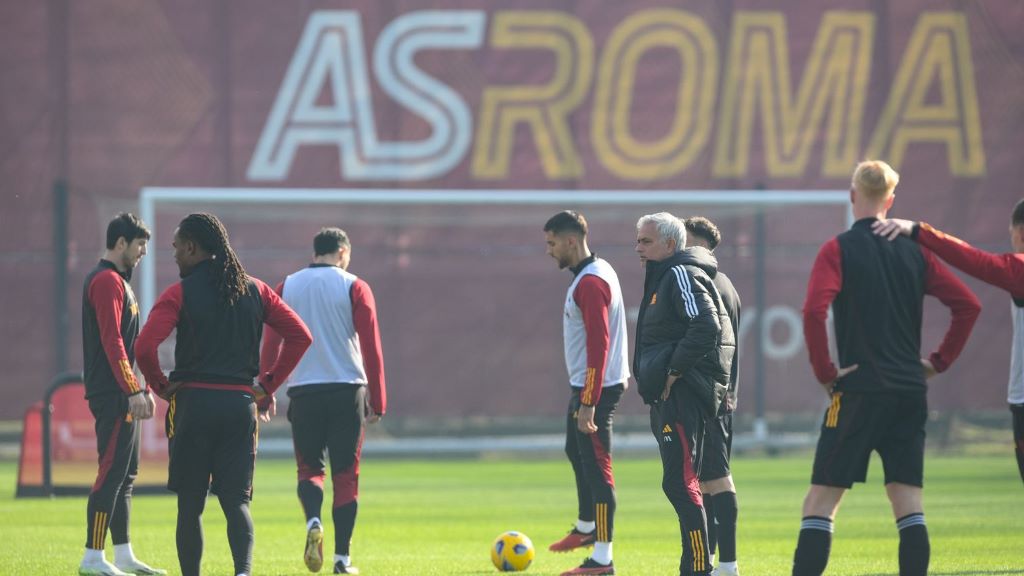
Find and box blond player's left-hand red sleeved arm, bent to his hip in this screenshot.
[804,238,843,384]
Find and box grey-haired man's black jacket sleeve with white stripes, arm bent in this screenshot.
[667,266,722,383]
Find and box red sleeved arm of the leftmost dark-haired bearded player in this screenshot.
[88,272,143,396]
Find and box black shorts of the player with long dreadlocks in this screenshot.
[165,388,258,501]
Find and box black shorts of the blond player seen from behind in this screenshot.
[811,393,928,488]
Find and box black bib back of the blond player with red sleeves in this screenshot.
[833,218,927,392]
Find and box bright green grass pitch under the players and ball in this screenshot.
[0,452,1024,576]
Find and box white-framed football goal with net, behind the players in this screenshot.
[138,188,850,444]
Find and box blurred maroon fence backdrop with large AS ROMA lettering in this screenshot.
[0,0,1024,475]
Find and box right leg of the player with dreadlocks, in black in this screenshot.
[210,390,259,574]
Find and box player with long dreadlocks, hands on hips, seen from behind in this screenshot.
[135,214,312,576]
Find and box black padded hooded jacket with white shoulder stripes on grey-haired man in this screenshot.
[633,246,736,415]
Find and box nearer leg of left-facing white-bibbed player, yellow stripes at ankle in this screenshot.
[563,384,623,576]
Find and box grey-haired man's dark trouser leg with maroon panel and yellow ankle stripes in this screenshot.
[656,386,712,576]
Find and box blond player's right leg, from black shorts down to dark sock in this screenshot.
[877,394,931,576]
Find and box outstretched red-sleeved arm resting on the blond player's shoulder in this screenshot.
[911,222,1024,298]
